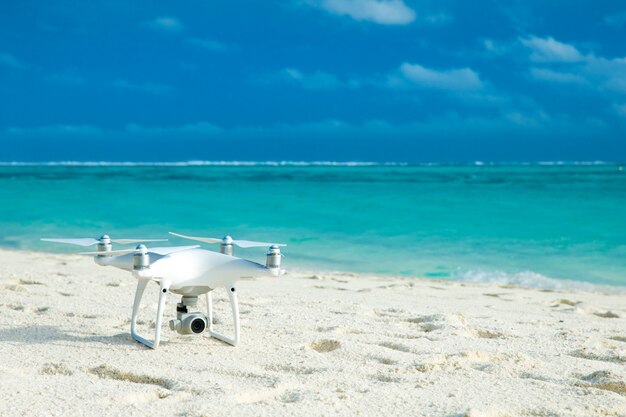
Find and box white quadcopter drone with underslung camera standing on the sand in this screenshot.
[41,232,287,349]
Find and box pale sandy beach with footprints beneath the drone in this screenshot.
[0,250,626,417]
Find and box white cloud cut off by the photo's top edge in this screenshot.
[313,0,415,25]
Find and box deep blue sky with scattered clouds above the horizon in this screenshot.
[0,0,626,162]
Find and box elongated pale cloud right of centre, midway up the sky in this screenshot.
[390,62,483,92]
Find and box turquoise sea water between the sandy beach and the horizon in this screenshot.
[0,165,626,286]
